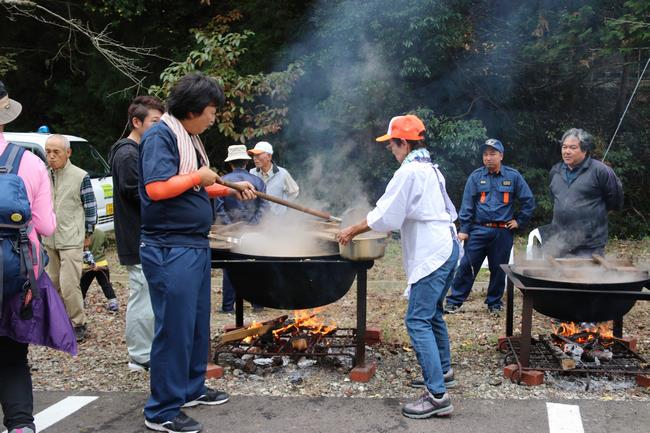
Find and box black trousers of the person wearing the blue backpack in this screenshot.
[0,337,36,431]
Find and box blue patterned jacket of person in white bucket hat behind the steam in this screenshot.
[214,168,269,224]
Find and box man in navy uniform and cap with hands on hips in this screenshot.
[445,138,535,314]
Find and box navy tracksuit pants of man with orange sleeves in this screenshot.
[140,244,210,423]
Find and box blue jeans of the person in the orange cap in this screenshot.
[406,242,458,394]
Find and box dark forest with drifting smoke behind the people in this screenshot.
[0,0,650,238]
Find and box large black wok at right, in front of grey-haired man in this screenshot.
[511,265,650,322]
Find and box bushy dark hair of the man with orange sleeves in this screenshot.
[167,72,225,120]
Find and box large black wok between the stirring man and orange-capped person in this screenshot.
[212,250,364,310]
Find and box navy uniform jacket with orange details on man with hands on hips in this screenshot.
[458,165,535,233]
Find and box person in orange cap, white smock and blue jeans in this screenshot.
[337,114,460,418]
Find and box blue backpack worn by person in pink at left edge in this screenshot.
[0,143,43,319]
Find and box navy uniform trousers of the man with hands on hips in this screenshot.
[447,225,513,307]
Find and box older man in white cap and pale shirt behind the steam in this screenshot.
[248,141,300,215]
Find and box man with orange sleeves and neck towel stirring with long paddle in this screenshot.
[139,73,255,433]
